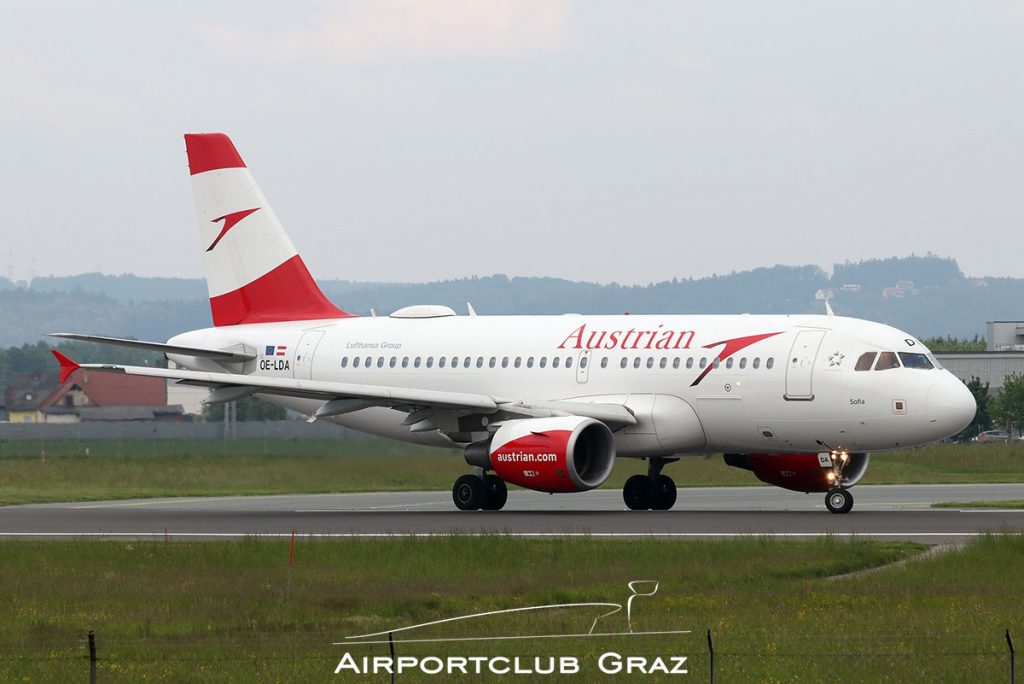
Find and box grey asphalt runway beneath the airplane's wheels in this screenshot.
[0,484,1024,544]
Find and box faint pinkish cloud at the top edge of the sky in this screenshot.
[195,0,569,59]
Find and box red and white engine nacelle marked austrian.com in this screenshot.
[466,416,615,491]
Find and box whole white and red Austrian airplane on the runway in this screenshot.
[53,133,976,513]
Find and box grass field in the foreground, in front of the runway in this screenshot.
[0,537,1024,683]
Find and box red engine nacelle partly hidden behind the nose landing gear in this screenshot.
[725,453,870,491]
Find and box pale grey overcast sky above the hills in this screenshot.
[0,0,1024,283]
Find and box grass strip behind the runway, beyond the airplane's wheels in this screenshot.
[0,438,1024,504]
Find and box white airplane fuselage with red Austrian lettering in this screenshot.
[170,311,975,457]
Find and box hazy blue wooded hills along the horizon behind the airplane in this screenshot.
[0,255,1024,346]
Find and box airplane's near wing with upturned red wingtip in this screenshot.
[53,350,637,433]
